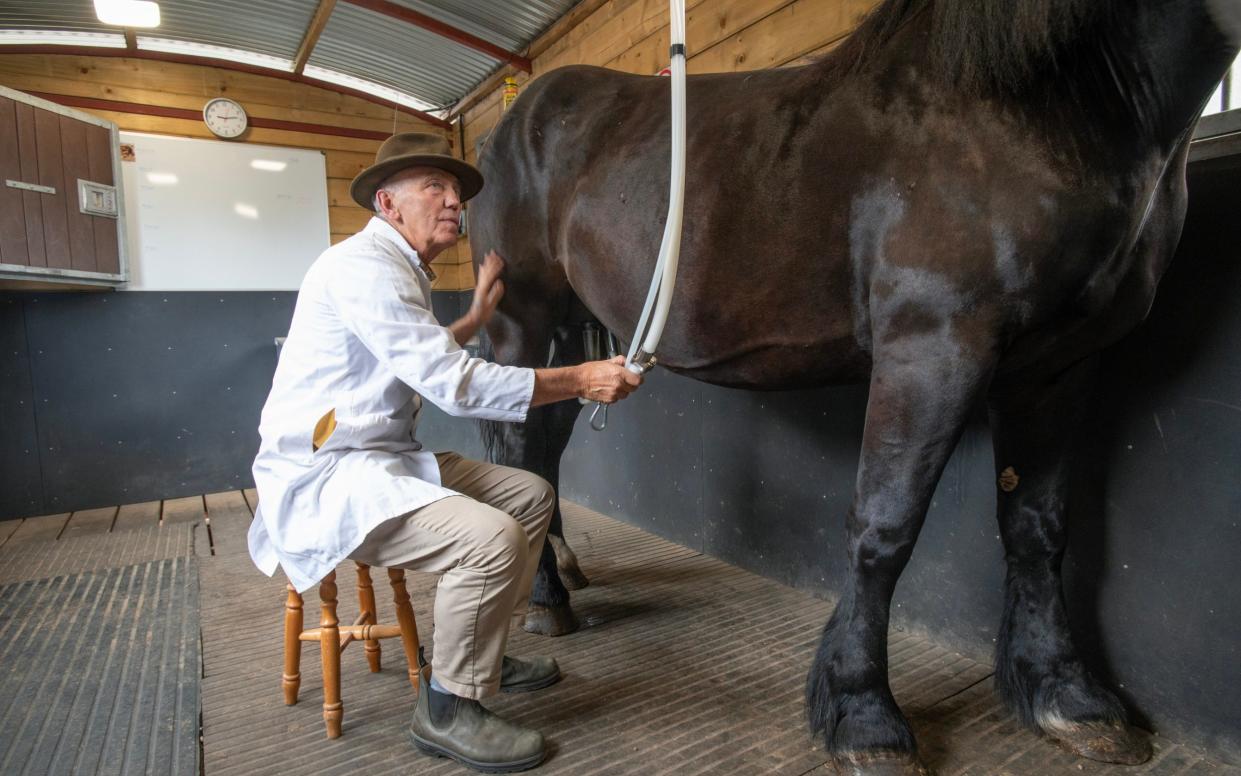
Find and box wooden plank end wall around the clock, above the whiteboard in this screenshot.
[0,53,473,291]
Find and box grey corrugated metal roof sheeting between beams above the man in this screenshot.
[0,0,577,107]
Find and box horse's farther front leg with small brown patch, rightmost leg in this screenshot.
[992,363,1150,765]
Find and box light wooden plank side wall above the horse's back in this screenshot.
[458,0,877,287]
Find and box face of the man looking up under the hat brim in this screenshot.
[379,168,462,263]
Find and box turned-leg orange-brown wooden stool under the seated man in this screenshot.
[283,564,419,739]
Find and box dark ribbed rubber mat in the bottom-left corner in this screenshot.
[0,557,202,776]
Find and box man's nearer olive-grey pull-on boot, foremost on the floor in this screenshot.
[410,665,546,774]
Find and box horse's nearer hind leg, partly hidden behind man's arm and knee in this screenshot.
[488,308,578,636]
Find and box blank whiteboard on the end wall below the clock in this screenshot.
[120,132,331,291]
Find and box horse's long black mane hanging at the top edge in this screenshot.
[823,0,1121,92]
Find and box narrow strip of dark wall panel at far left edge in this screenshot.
[0,294,48,519]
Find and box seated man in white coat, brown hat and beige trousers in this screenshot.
[249,133,642,771]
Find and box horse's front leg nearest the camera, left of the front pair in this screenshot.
[807,324,994,776]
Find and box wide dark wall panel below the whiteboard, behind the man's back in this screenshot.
[5,292,294,517]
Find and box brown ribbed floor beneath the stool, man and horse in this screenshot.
[0,492,1241,776]
